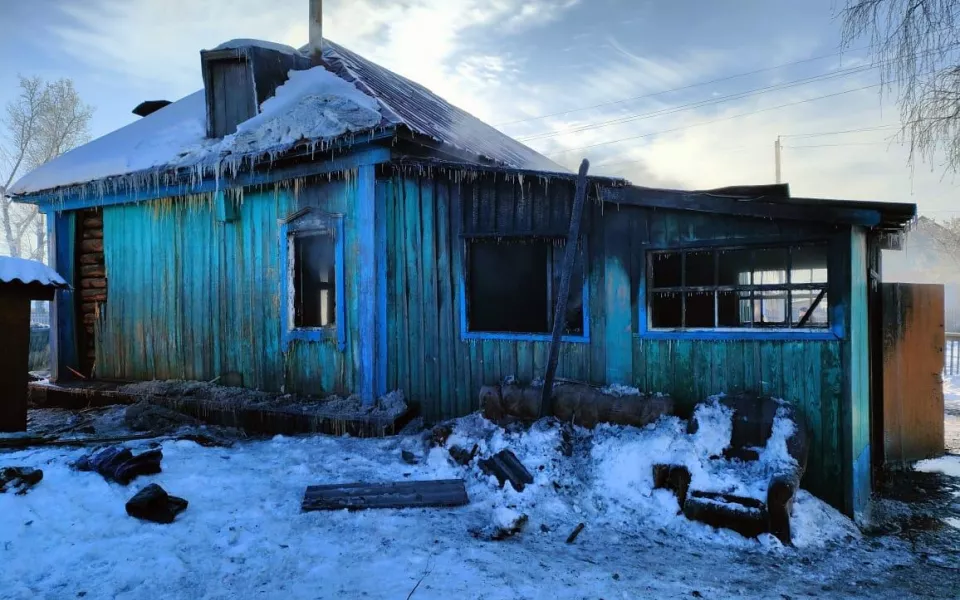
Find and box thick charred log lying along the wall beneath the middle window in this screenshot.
[480,381,673,428]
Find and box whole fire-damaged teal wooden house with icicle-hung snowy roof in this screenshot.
[11,23,915,514]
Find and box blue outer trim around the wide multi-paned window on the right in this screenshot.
[633,238,844,342]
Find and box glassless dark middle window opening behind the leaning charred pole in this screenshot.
[466,238,584,335]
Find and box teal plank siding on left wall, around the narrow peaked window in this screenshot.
[97,175,373,394]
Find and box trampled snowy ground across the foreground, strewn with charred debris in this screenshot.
[0,400,960,600]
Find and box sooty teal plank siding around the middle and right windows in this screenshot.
[386,177,850,506]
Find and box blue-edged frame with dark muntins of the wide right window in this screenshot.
[637,238,844,341]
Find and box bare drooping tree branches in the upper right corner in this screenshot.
[841,0,960,171]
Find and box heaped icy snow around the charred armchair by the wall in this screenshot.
[436,406,859,547]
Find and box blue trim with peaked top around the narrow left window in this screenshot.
[280,209,347,352]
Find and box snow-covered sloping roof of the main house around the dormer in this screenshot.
[9,40,566,195]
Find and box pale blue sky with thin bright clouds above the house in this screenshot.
[0,0,960,218]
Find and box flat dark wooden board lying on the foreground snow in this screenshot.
[302,479,470,511]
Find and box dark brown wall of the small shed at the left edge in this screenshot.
[0,285,30,432]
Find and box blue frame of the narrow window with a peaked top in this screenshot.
[279,208,347,352]
